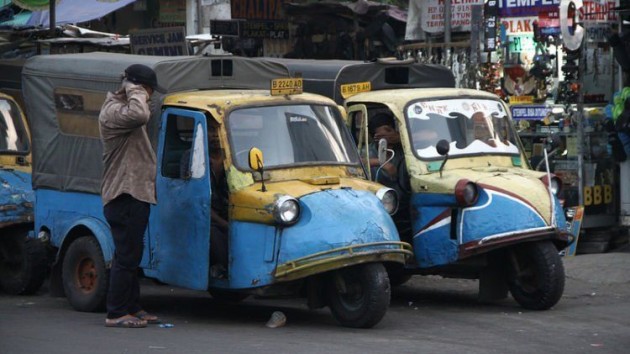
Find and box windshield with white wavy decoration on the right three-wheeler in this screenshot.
[405,98,519,159]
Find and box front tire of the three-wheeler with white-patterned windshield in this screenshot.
[508,241,565,310]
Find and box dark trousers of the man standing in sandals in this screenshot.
[103,194,150,318]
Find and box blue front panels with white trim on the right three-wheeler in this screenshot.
[411,189,566,268]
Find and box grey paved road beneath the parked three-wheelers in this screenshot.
[0,253,630,354]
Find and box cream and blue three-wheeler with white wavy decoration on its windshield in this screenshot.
[274,59,571,310]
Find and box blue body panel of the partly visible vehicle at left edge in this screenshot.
[0,169,35,226]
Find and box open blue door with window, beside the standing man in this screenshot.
[149,108,211,290]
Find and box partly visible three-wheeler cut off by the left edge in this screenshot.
[0,93,47,294]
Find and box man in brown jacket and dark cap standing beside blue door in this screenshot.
[99,64,164,328]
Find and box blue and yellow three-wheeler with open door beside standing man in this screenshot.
[23,53,411,327]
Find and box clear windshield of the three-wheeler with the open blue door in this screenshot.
[227,104,359,170]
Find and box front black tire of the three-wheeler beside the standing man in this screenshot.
[326,263,391,328]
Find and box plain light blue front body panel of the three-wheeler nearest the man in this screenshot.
[230,189,399,288]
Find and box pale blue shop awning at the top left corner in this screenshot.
[0,0,136,27]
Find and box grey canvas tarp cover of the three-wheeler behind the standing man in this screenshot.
[22,52,288,194]
